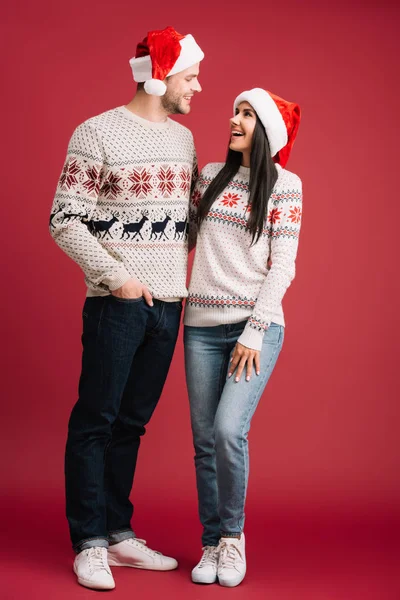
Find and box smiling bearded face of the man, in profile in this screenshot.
[161,63,201,115]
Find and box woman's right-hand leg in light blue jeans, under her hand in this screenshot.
[214,323,284,537]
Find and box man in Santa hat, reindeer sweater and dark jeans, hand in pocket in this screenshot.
[50,27,204,589]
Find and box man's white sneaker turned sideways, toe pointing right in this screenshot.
[108,538,178,571]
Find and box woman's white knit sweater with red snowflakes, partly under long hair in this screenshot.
[184,163,302,350]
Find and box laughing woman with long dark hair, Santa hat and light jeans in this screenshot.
[184,88,301,587]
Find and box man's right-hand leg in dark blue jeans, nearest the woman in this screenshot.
[105,300,182,543]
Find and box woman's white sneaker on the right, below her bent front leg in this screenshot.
[217,533,246,587]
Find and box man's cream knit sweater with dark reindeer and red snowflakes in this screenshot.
[50,107,197,299]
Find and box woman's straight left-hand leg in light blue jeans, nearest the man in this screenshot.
[184,326,229,546]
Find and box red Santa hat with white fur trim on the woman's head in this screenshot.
[233,88,300,167]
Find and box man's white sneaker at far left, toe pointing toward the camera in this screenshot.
[74,546,115,590]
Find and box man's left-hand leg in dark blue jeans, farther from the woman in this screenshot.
[65,296,147,552]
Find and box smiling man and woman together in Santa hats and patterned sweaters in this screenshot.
[50,27,301,589]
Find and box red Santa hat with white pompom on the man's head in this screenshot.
[129,27,204,96]
